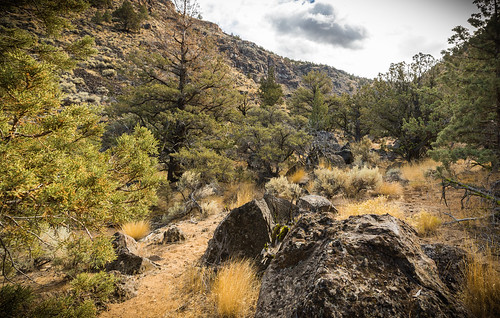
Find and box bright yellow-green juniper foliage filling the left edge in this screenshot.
[0,3,159,275]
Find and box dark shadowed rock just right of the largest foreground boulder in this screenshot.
[422,243,467,293]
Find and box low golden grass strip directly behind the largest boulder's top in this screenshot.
[339,196,405,220]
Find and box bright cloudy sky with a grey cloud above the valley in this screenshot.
[194,0,476,78]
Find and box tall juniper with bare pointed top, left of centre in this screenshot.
[109,0,237,181]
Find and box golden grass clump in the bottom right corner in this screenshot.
[461,249,500,317]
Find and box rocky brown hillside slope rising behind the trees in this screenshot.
[0,0,366,103]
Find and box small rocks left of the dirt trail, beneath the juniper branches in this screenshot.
[106,232,156,275]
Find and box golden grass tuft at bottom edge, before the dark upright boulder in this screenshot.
[210,260,260,318]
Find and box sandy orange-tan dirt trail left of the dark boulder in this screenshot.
[99,214,224,318]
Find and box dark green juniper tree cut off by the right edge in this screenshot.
[431,0,500,169]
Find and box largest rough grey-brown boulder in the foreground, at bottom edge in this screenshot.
[255,213,468,318]
